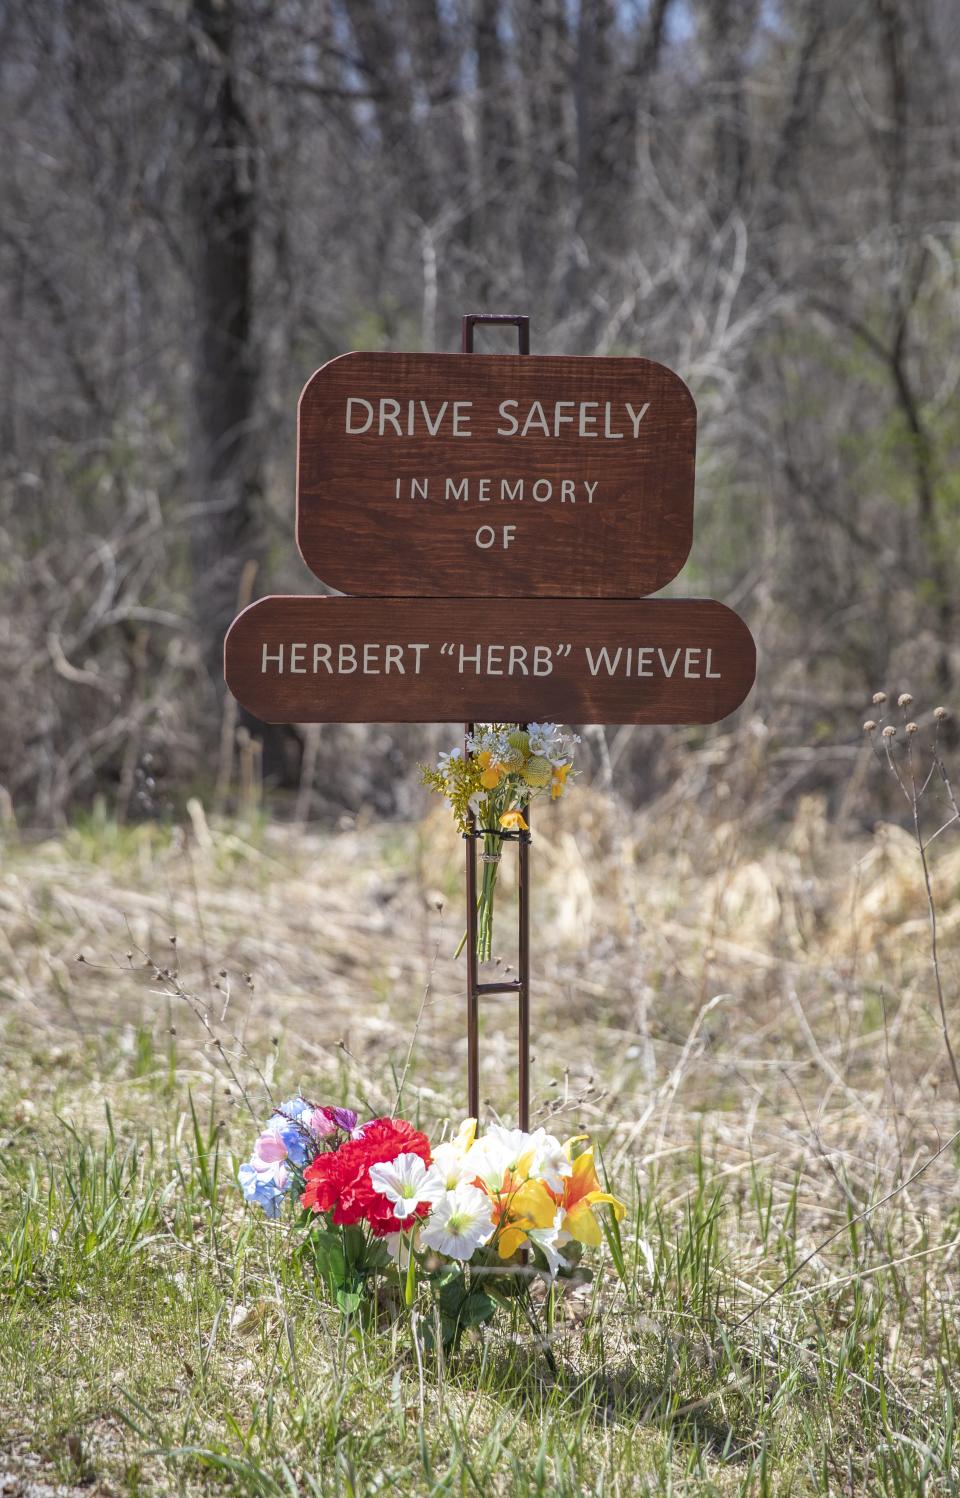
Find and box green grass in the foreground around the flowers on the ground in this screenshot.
[0,1040,957,1498]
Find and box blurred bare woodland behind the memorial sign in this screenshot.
[0,0,960,825]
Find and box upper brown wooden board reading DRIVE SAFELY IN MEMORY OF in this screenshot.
[297,354,696,598]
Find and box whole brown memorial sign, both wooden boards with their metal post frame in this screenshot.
[225,315,756,1129]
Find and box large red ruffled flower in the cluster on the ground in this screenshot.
[300,1119,430,1237]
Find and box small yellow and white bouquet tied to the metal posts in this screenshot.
[422,724,580,962]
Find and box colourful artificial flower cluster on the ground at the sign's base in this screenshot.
[238,1097,625,1347]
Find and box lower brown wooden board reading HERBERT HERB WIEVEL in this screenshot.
[225,598,756,724]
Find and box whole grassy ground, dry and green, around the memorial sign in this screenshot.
[0,808,960,1498]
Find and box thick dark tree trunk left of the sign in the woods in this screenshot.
[184,0,262,680]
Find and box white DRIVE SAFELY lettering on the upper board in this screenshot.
[343,395,650,442]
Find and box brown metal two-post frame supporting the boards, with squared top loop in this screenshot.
[461,313,530,1129]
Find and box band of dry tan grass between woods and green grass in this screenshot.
[7,743,960,1209]
